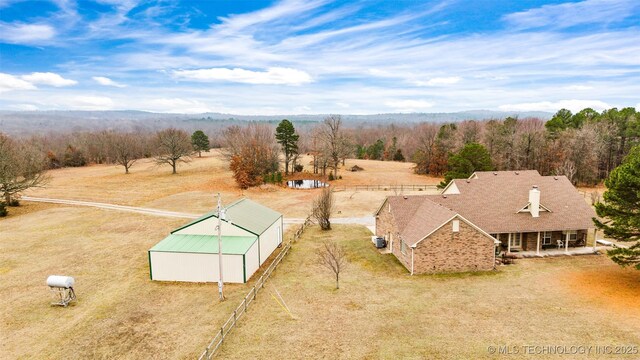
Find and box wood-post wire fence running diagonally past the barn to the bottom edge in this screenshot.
[198,216,313,360]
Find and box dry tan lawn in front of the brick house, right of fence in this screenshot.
[220,225,640,359]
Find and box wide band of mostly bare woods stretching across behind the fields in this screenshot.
[0,108,640,214]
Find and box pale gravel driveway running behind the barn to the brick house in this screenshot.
[21,196,375,232]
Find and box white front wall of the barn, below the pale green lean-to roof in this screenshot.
[150,251,244,283]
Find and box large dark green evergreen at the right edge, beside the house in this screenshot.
[593,145,640,270]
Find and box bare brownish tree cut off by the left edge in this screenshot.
[0,133,48,205]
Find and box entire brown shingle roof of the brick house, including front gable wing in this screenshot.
[378,170,596,245]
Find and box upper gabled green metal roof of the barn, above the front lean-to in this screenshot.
[172,198,282,235]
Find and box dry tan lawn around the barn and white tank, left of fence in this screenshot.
[0,203,270,359]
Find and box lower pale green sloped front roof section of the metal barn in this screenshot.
[149,234,258,255]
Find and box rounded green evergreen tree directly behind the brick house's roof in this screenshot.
[438,143,493,188]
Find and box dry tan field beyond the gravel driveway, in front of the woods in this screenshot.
[21,150,440,218]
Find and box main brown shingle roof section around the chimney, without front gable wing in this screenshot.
[426,170,596,233]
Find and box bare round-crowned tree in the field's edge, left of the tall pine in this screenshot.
[156,128,193,174]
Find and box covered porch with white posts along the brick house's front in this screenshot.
[491,229,595,256]
